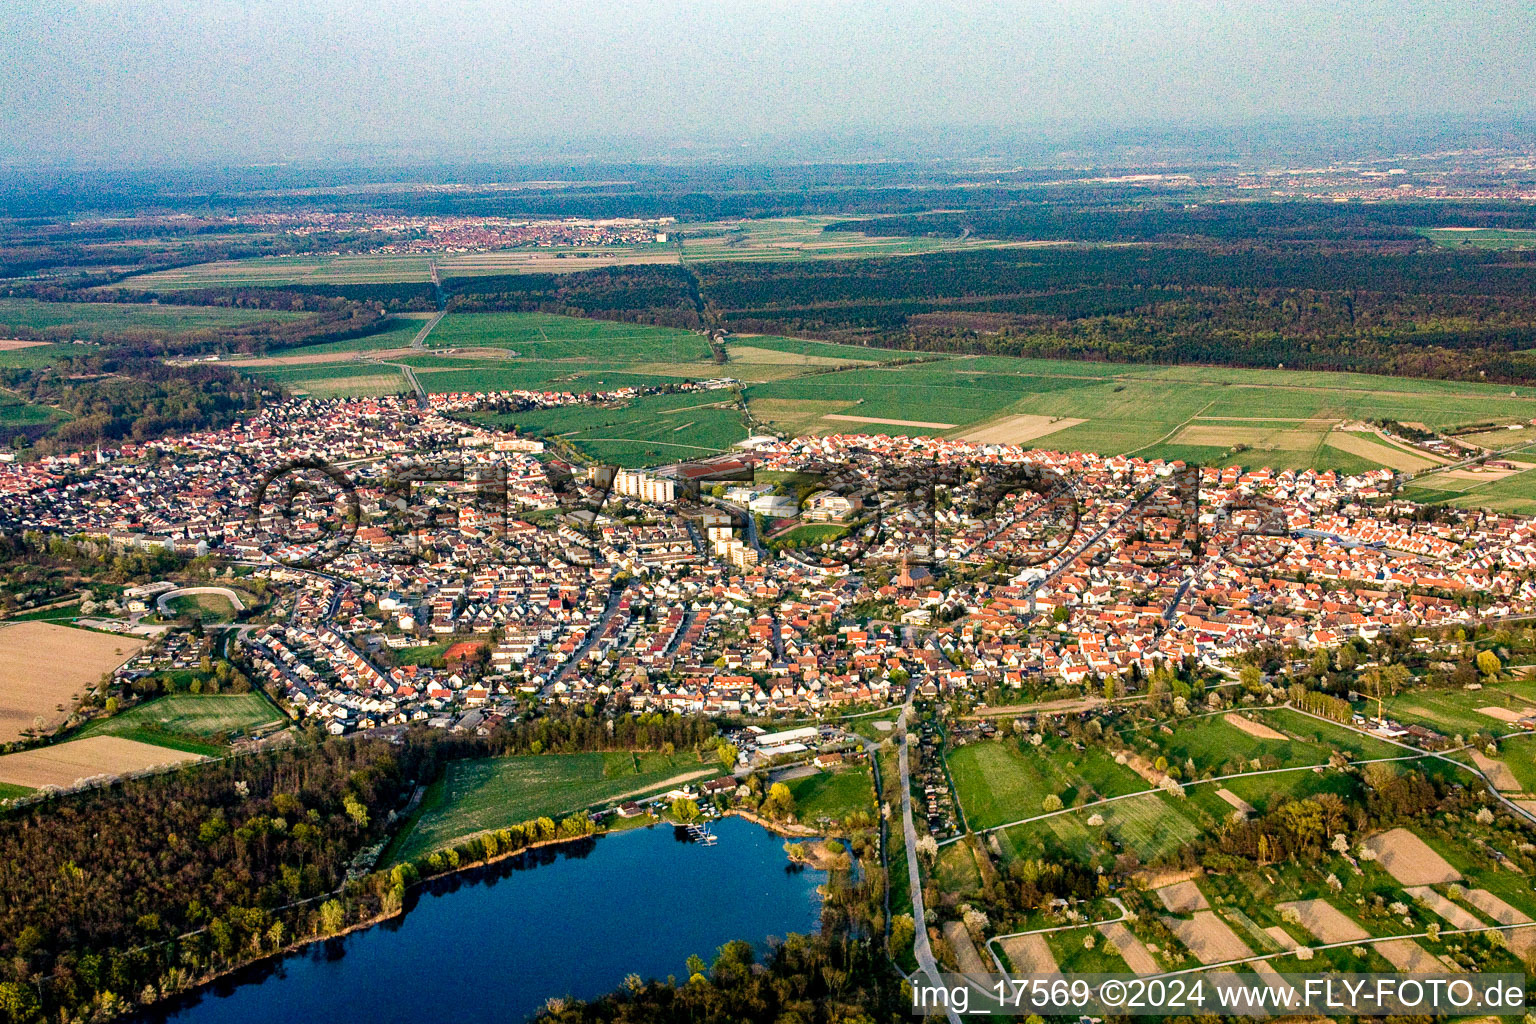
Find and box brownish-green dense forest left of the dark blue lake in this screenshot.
[0,742,425,1021]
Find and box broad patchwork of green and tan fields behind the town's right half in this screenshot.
[746,353,1536,479]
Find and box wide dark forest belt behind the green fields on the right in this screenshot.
[697,246,1536,382]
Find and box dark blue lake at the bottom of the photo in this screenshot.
[154,818,826,1024]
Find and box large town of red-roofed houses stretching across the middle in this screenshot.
[0,382,1536,734]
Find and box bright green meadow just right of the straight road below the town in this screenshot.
[948,740,1147,829]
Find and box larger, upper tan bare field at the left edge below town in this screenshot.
[0,622,144,743]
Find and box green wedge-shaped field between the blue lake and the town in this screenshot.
[393,752,722,860]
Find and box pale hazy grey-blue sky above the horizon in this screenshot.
[0,0,1536,163]
